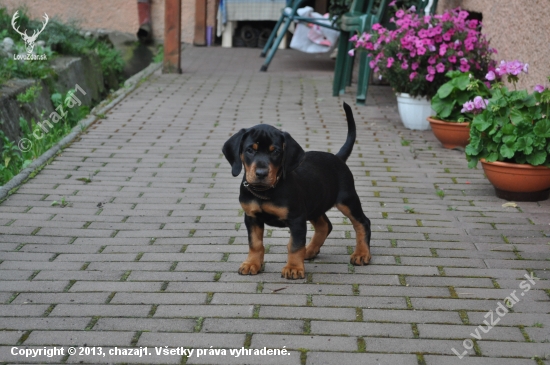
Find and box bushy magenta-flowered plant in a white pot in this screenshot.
[351,6,495,129]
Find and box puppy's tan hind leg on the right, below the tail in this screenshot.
[336,204,371,266]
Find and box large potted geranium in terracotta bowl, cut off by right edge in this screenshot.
[466,61,550,201]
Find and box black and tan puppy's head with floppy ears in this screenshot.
[222,124,305,186]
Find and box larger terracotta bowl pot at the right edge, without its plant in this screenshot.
[480,159,550,201]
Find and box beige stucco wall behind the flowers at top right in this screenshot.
[437,0,550,91]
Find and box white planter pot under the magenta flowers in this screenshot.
[396,93,436,131]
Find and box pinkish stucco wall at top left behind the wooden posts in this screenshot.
[0,0,203,43]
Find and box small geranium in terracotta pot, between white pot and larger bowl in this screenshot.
[428,71,491,148]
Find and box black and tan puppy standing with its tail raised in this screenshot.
[222,103,371,279]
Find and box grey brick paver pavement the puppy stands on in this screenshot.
[0,47,550,365]
